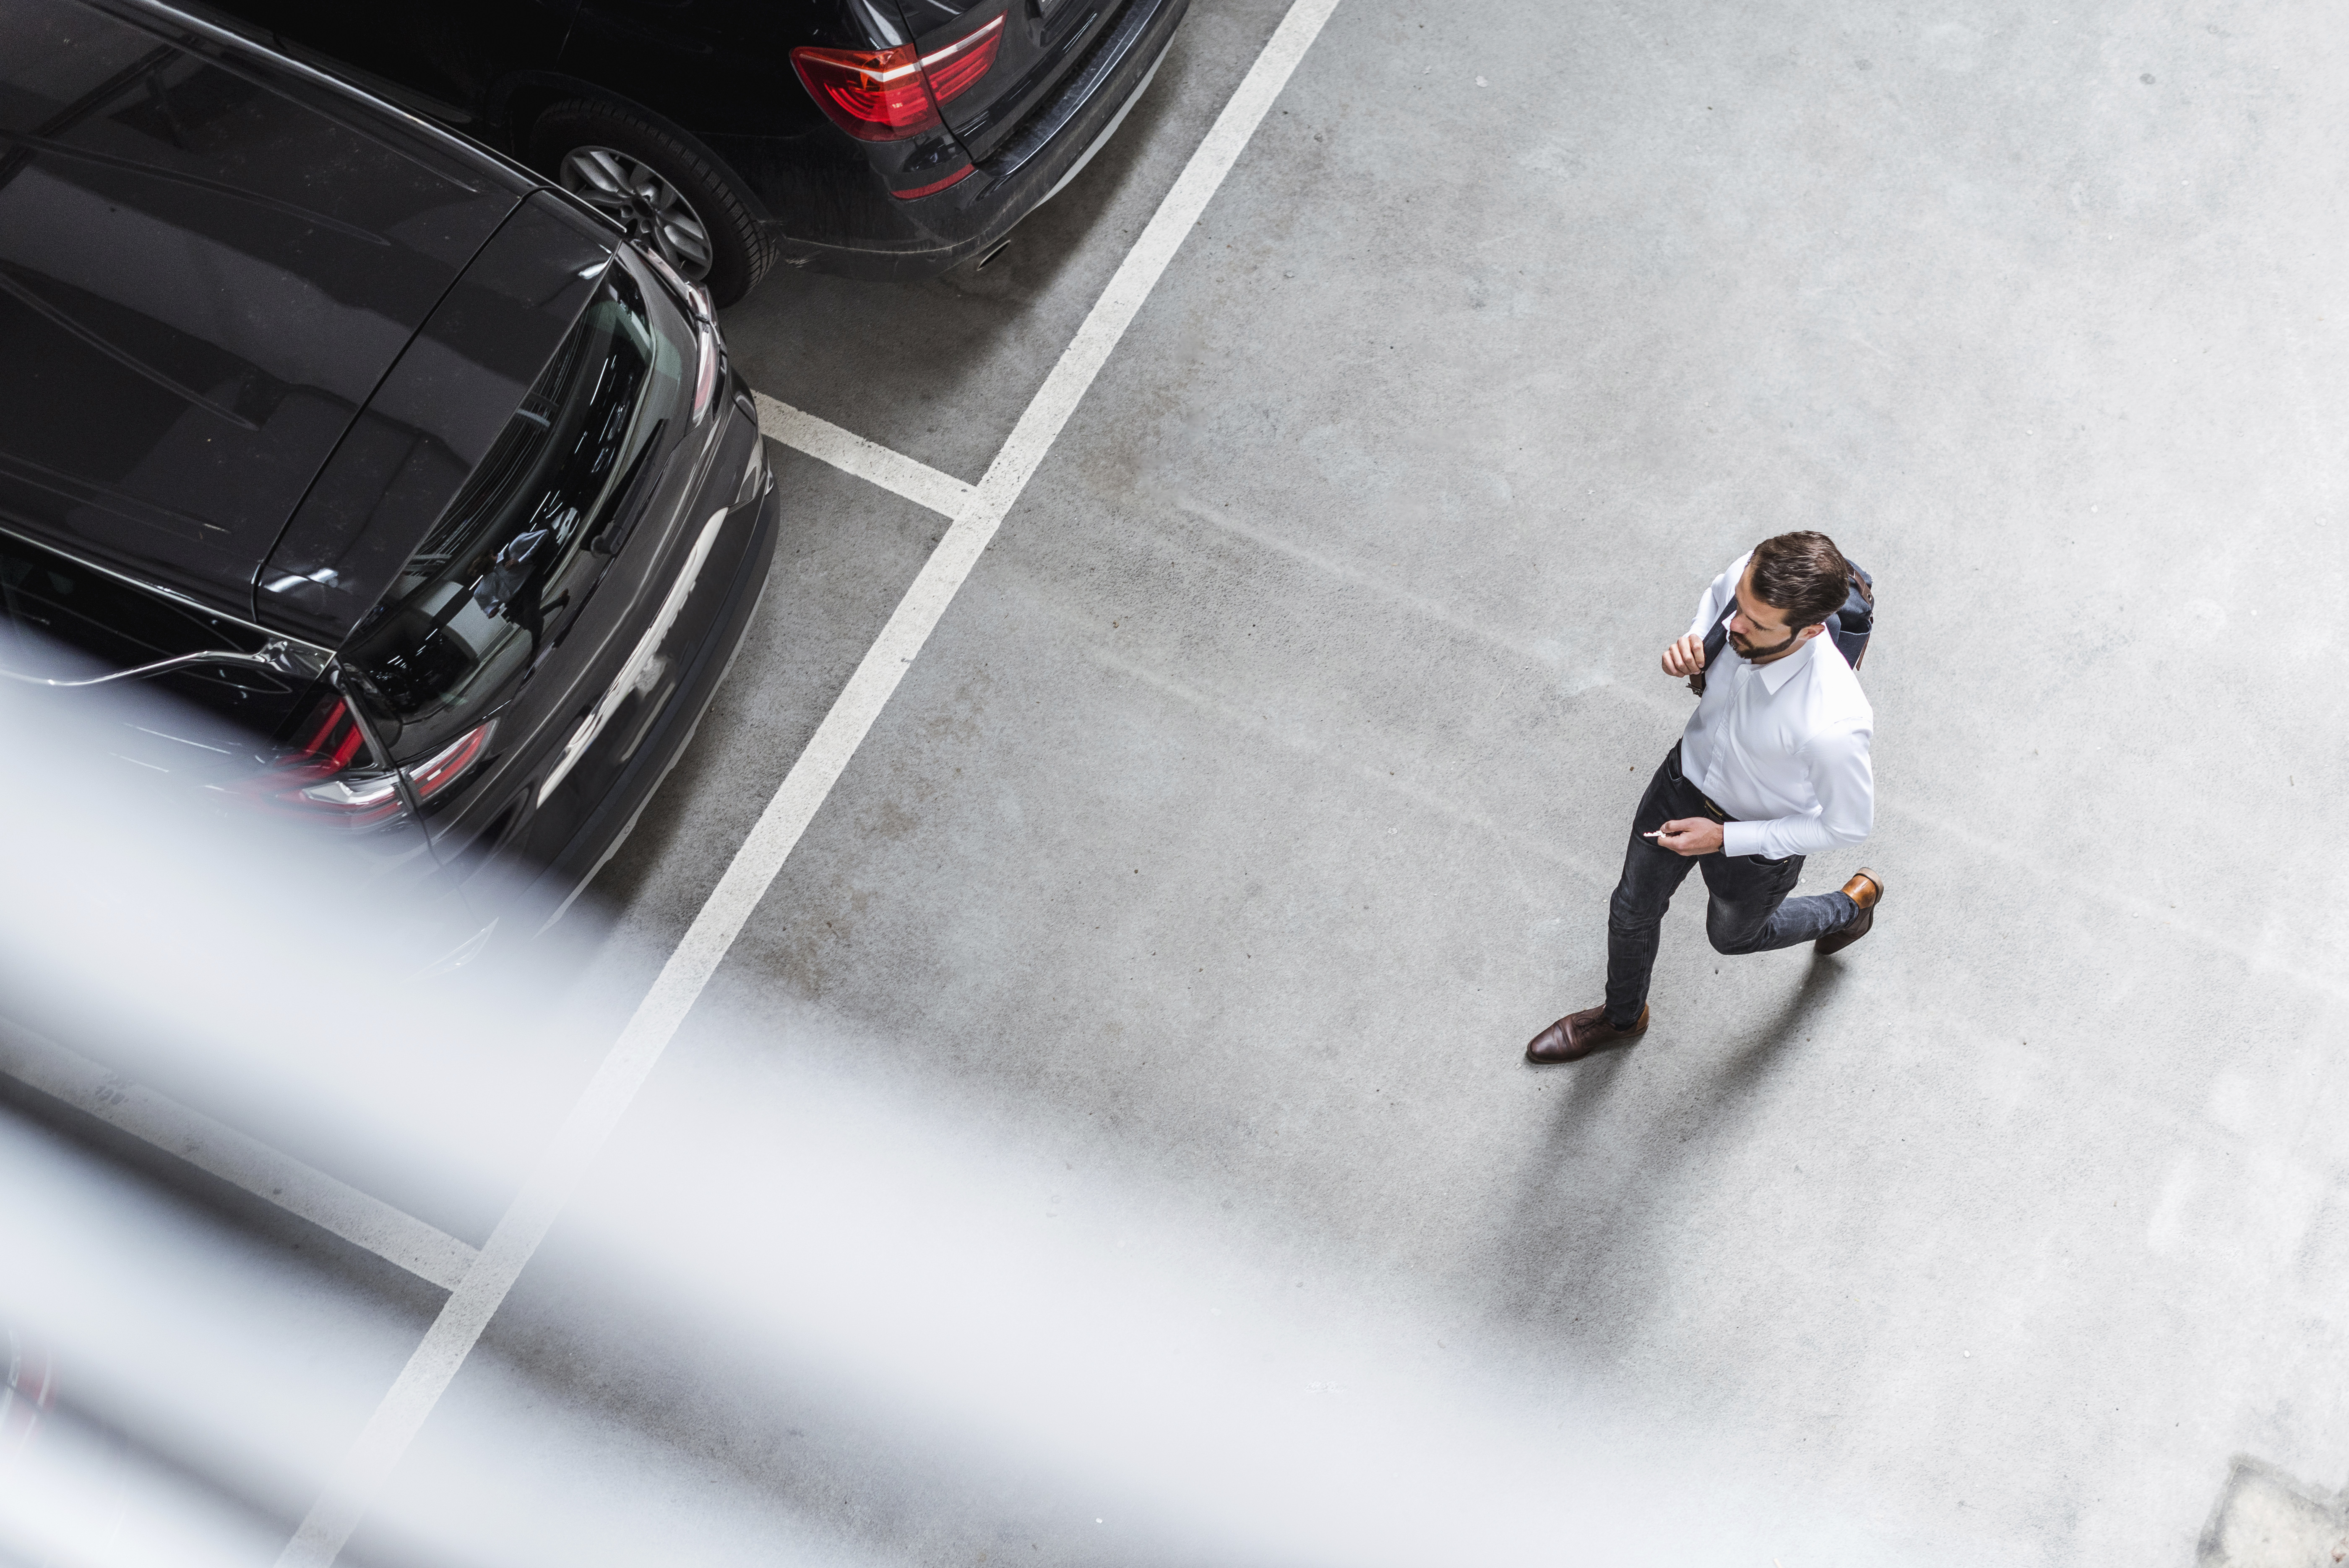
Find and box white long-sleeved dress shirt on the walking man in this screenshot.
[1680,552,1877,859]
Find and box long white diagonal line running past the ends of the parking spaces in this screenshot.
[277,0,1339,1568]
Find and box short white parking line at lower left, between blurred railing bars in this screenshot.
[0,1024,477,1291]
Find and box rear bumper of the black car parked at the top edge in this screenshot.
[766,0,1191,279]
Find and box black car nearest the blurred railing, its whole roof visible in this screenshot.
[0,0,778,958]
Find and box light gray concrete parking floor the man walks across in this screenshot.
[298,0,2349,1568]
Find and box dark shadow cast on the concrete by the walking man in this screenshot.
[1487,958,1846,1352]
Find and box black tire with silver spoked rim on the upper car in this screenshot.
[529,99,773,305]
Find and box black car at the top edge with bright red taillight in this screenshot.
[190,0,1189,305]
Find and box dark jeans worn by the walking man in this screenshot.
[1607,744,1860,1028]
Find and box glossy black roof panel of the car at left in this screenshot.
[0,0,526,617]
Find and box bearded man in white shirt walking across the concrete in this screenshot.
[1524,533,1884,1063]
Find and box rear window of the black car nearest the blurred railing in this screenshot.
[343,260,686,763]
